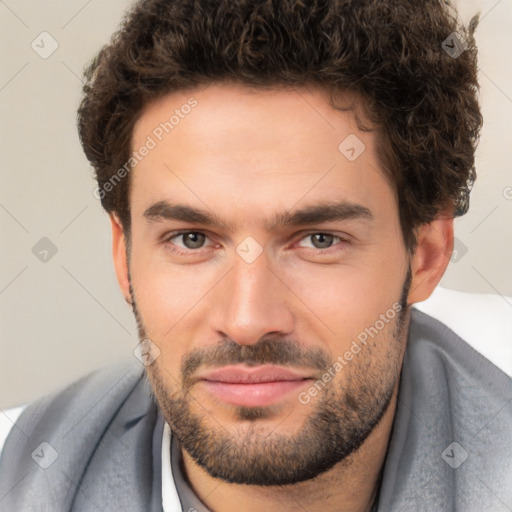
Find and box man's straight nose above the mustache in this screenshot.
[210,247,295,345]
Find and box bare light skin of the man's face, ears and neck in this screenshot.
[111,84,453,512]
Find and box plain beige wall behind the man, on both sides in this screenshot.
[0,0,512,408]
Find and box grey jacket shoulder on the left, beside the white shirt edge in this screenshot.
[0,362,158,510]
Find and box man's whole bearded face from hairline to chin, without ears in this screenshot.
[122,85,410,485]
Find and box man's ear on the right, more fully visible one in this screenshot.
[407,218,453,304]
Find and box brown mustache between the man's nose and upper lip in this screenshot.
[181,337,330,382]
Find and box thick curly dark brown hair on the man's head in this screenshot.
[78,0,482,249]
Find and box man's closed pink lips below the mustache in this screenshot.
[198,365,312,407]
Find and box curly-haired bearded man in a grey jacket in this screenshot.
[0,0,512,512]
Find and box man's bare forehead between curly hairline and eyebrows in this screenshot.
[130,84,394,228]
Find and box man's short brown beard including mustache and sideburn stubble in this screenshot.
[130,269,411,486]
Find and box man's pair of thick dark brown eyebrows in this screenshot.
[143,201,374,232]
